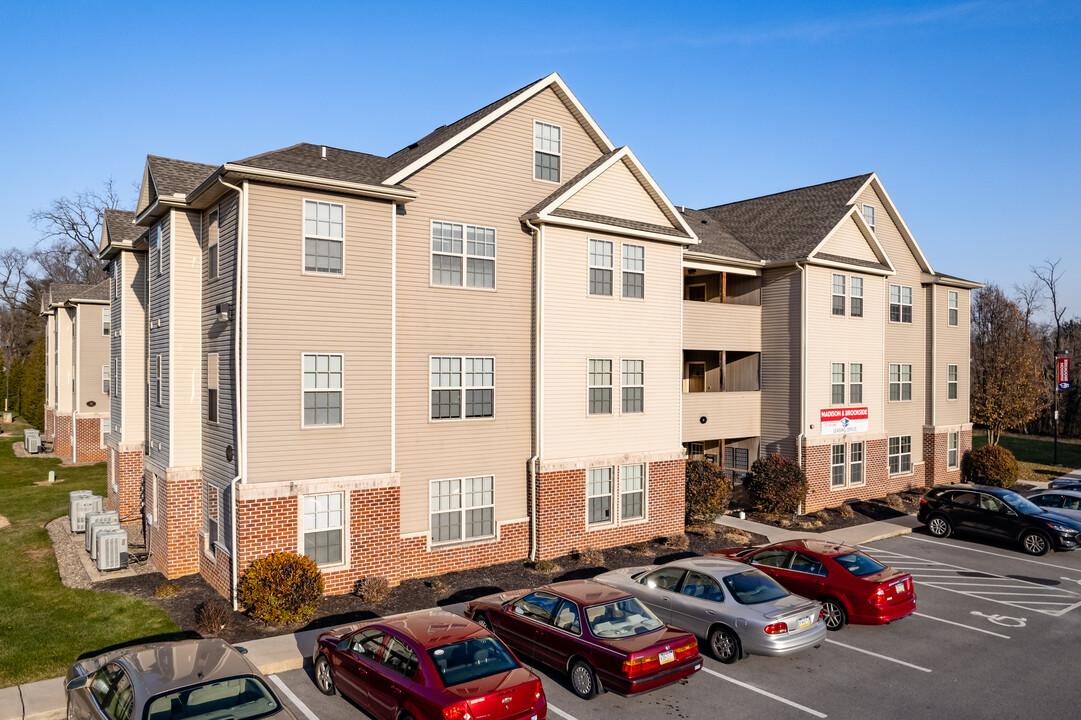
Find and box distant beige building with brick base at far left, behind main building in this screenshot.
[41,282,110,463]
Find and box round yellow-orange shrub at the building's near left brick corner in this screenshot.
[237,552,323,625]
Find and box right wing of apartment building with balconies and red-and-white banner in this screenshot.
[683,173,980,510]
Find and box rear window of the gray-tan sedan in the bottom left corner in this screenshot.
[145,676,281,720]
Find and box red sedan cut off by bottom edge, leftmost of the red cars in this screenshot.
[312,610,548,720]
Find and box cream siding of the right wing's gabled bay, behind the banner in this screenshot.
[804,265,882,432]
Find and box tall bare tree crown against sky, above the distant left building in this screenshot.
[30,177,120,283]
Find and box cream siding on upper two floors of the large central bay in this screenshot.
[541,226,683,461]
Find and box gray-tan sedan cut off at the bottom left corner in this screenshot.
[66,640,296,720]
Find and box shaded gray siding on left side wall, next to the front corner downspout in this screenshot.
[200,192,239,551]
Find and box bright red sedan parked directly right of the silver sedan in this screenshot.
[709,539,916,630]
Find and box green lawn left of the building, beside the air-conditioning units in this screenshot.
[0,423,183,688]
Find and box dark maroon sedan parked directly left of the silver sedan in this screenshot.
[466,581,702,699]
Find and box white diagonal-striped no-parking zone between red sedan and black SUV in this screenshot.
[863,535,1081,617]
